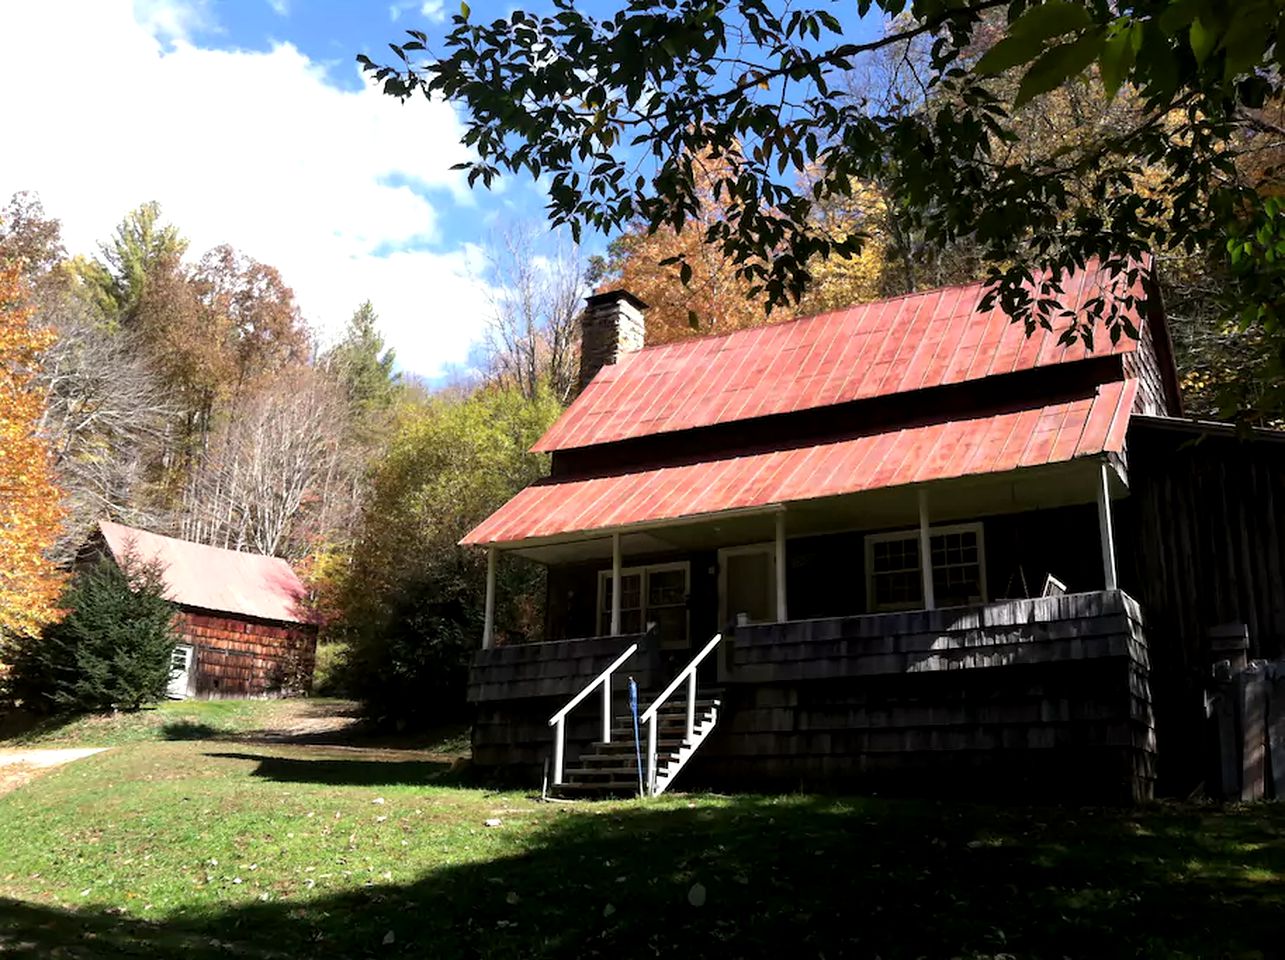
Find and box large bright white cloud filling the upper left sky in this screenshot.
[0,0,487,375]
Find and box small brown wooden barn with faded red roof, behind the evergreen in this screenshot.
[90,520,317,699]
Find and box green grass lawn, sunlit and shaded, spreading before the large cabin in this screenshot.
[0,740,1285,960]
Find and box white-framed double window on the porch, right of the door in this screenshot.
[866,523,986,610]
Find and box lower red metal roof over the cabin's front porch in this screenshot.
[460,380,1137,544]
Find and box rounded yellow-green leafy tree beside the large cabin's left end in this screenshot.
[336,387,562,722]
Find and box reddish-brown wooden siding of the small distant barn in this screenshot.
[177,608,316,699]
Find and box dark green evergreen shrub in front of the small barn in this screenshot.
[6,556,179,713]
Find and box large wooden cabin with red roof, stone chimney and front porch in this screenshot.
[461,263,1285,802]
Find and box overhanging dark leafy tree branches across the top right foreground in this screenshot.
[359,0,1285,372]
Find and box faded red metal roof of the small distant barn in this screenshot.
[98,520,307,623]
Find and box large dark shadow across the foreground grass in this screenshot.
[0,798,1285,960]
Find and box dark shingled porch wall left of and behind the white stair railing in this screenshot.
[469,634,654,784]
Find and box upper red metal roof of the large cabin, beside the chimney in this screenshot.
[533,260,1141,451]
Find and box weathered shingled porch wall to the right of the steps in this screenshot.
[693,591,1155,801]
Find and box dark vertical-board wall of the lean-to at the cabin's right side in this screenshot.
[1118,418,1285,796]
